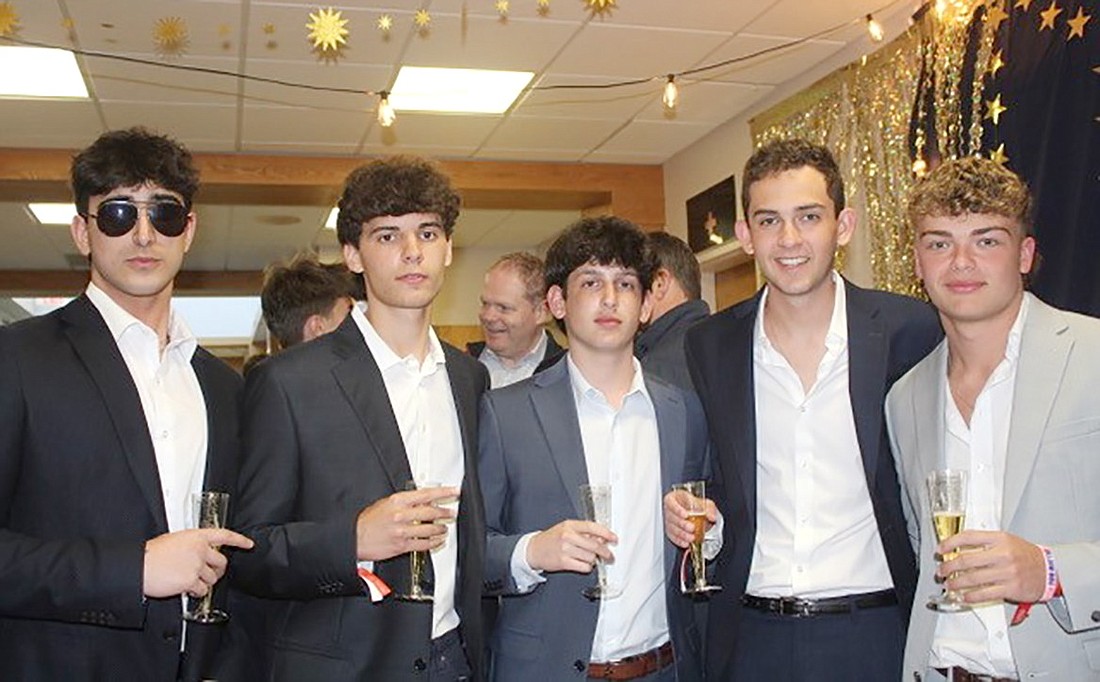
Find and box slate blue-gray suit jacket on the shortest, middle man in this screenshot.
[479,360,707,682]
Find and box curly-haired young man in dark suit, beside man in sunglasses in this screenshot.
[233,157,488,682]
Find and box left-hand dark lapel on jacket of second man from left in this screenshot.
[332,315,413,492]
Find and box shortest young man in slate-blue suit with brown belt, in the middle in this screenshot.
[479,217,716,682]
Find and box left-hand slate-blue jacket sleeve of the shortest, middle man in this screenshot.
[477,394,523,594]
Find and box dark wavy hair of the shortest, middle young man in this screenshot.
[547,216,657,296]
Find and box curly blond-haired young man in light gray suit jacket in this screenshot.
[887,158,1100,682]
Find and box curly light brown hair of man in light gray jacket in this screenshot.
[908,156,1032,237]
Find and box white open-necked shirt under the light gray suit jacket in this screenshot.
[922,296,1029,678]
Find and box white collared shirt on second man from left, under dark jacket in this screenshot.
[351,307,465,639]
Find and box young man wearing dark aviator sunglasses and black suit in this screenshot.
[0,129,252,682]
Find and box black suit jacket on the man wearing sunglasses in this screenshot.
[0,296,241,682]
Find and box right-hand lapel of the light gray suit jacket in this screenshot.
[1001,294,1074,530]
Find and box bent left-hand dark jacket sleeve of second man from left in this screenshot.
[233,363,364,600]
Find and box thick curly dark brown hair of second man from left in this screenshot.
[337,156,462,245]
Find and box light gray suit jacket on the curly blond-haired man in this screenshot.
[887,294,1100,681]
